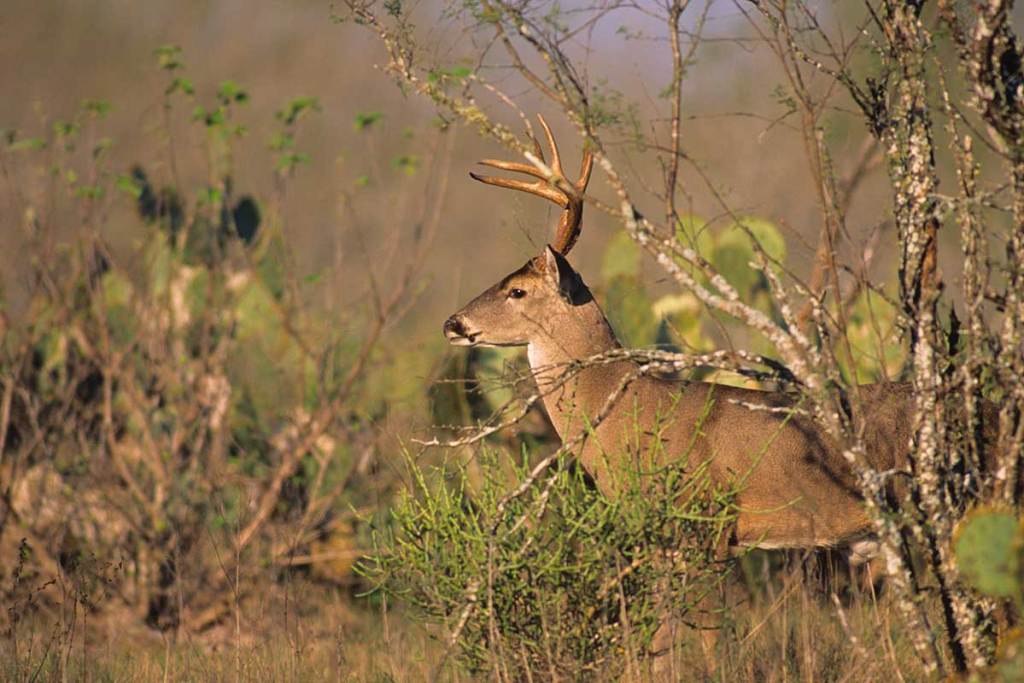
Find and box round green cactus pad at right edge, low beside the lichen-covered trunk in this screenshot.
[953,510,1021,599]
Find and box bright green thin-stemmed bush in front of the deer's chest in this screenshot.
[361,444,733,679]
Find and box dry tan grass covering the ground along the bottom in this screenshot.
[0,555,924,683]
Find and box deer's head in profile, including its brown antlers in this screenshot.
[444,116,603,346]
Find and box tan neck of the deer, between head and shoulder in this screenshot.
[526,300,632,442]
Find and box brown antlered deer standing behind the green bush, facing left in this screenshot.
[443,117,929,671]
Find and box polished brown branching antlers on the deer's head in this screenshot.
[469,114,594,256]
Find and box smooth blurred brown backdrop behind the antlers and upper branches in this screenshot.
[0,0,886,325]
